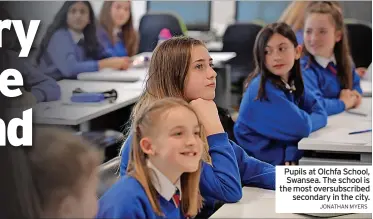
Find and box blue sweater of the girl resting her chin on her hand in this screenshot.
[120,133,276,216]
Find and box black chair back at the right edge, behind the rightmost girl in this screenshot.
[345,19,372,68]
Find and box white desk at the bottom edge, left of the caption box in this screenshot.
[210,187,372,219]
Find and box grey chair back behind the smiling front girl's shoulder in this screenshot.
[97,156,121,198]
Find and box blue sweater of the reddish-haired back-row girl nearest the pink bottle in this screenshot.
[97,27,128,57]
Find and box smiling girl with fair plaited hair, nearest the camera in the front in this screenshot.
[96,98,203,219]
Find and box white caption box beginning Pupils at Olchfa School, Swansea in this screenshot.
[276,166,373,213]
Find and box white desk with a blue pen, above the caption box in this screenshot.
[298,97,372,165]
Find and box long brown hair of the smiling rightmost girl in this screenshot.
[303,1,353,89]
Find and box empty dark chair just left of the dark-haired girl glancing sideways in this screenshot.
[222,23,263,108]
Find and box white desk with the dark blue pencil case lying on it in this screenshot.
[34,80,141,131]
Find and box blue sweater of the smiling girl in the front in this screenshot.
[96,176,185,219]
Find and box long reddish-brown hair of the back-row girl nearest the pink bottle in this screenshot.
[100,1,139,56]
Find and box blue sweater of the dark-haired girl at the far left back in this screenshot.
[39,28,109,80]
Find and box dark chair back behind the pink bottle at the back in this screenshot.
[139,12,186,53]
